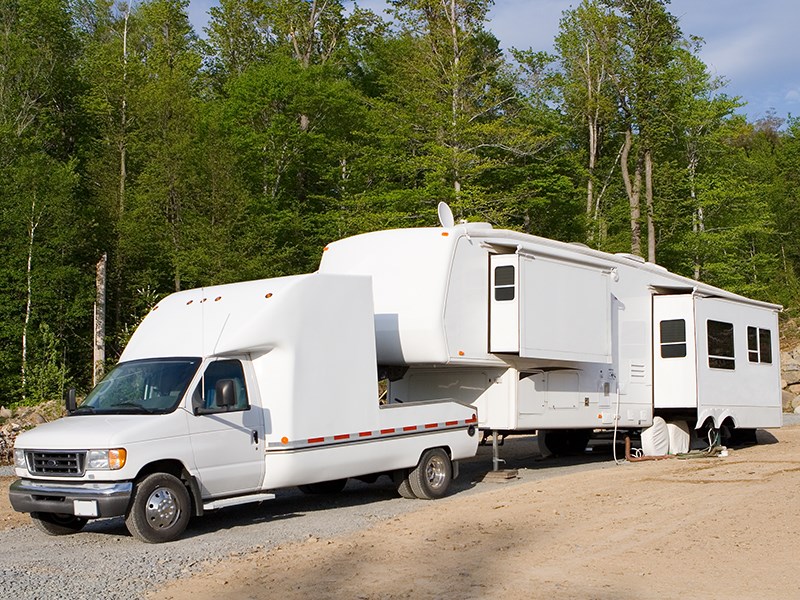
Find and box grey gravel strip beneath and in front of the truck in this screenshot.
[0,415,800,600]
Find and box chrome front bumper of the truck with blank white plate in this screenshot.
[8,479,133,517]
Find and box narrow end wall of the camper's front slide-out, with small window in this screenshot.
[489,254,520,354]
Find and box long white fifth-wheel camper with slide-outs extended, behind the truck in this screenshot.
[320,204,781,452]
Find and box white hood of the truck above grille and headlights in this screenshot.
[14,408,186,450]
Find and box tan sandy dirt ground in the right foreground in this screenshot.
[153,427,800,600]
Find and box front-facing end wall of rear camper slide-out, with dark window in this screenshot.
[653,294,697,409]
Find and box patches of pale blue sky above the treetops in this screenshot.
[189,0,800,120]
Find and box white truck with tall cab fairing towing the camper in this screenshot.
[9,273,478,542]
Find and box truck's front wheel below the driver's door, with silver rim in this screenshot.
[125,473,192,544]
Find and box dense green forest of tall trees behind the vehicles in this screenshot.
[0,0,800,405]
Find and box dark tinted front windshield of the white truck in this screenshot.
[73,358,200,414]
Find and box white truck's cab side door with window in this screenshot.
[189,359,264,497]
